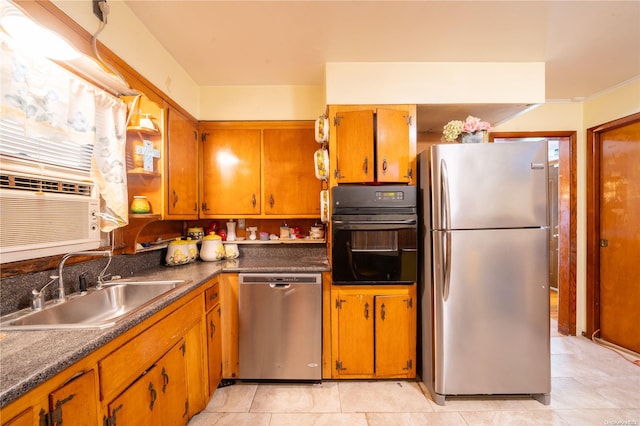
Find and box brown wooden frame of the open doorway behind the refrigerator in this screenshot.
[489,131,578,336]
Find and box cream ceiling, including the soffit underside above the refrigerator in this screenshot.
[124,0,640,131]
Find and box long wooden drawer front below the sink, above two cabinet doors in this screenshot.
[98,297,202,399]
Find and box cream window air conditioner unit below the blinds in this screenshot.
[0,161,100,263]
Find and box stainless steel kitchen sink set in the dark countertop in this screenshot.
[0,280,189,330]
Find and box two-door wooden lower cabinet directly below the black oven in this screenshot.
[332,284,416,379]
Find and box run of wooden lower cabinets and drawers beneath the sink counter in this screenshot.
[0,282,225,426]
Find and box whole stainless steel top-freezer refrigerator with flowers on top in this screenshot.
[419,141,551,405]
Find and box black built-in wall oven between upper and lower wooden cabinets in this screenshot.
[331,185,418,285]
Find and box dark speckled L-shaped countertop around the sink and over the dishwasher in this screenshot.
[0,253,330,408]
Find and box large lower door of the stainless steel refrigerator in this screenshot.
[433,228,551,395]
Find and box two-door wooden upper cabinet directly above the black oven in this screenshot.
[330,106,416,184]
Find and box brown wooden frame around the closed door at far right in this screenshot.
[584,113,640,337]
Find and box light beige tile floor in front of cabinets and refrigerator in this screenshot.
[189,292,640,426]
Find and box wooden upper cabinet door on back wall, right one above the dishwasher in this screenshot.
[263,128,322,216]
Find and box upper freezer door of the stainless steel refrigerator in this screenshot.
[431,141,548,229]
